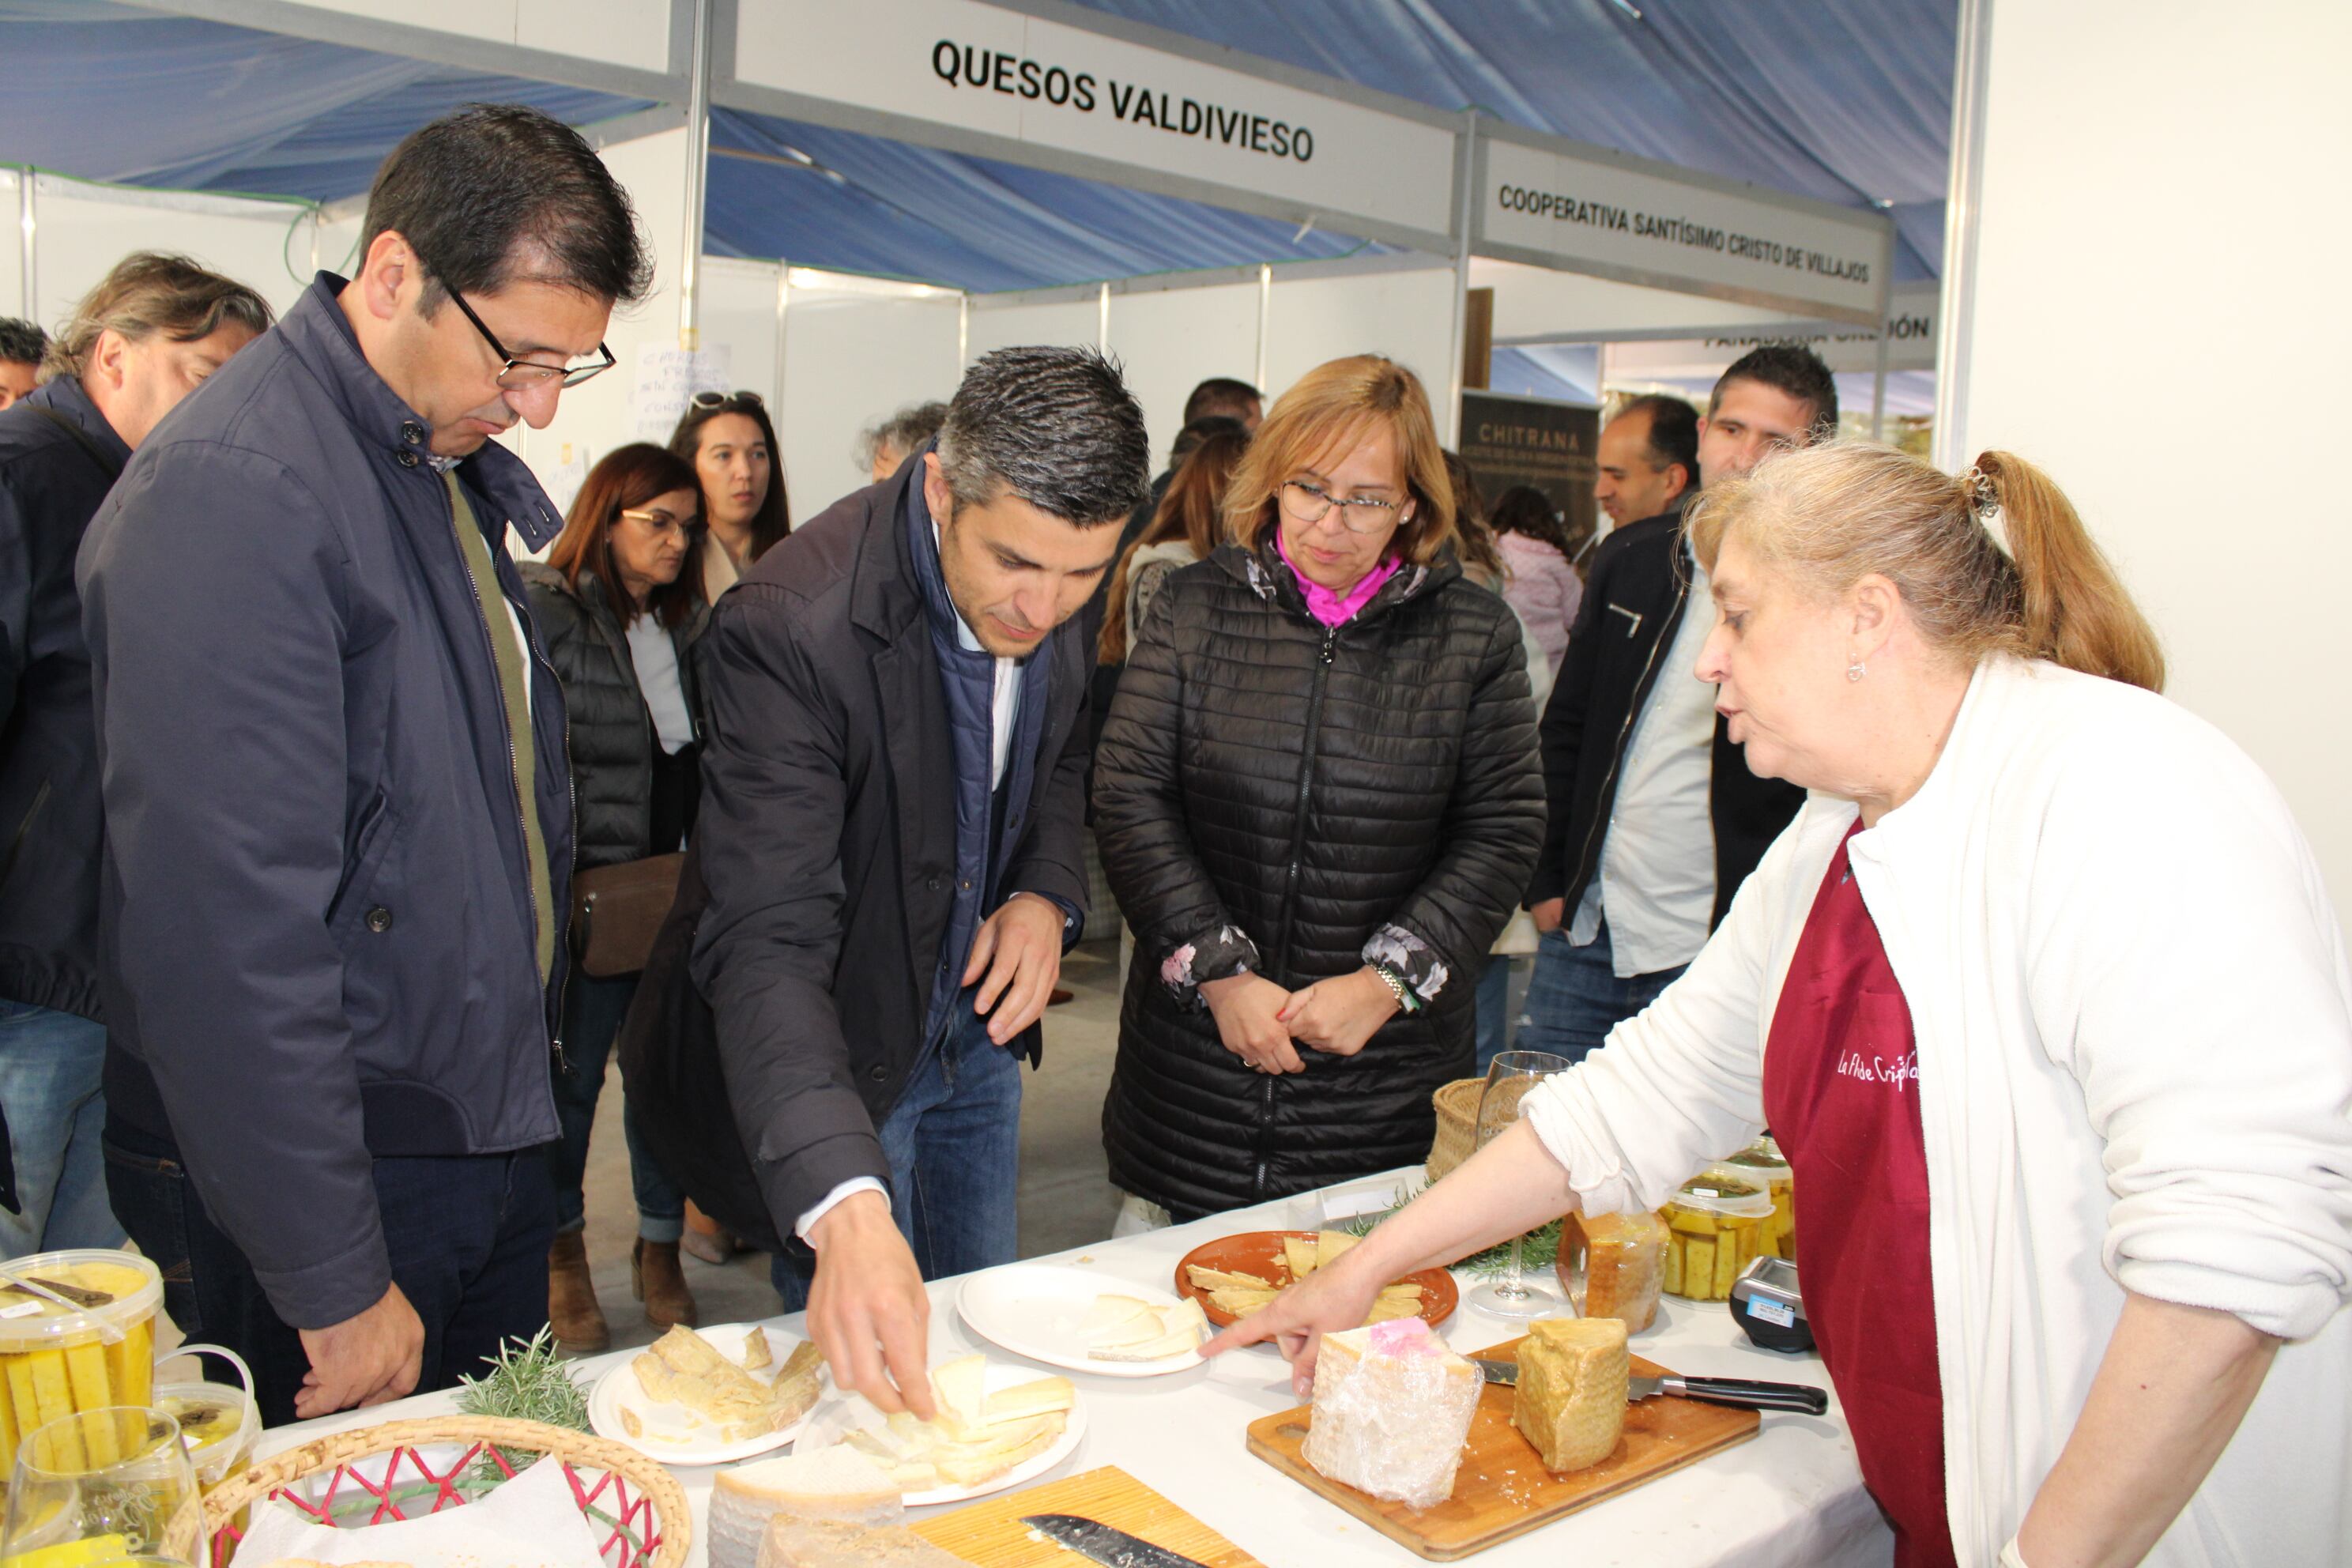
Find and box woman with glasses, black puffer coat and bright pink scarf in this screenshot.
[1094,355,1543,1220]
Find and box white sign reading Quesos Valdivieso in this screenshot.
[734,0,1453,235]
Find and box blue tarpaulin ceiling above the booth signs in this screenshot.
[0,0,1957,289]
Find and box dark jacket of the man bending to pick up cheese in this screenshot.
[686,463,1094,1234]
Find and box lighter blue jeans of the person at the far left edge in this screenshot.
[0,1001,122,1257]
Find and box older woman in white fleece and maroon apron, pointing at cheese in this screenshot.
[1214,447,2352,1568]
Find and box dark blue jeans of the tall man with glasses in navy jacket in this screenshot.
[106,1121,555,1427]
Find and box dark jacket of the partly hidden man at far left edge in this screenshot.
[0,376,132,1018]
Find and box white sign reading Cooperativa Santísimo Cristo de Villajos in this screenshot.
[1477,138,1886,320]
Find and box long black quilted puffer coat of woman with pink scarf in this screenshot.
[1094,545,1543,1218]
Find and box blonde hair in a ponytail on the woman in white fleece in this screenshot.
[1689,442,2164,692]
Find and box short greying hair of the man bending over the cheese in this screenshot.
[938,348,1150,526]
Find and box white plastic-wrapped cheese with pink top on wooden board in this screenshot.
[1301,1317,1479,1510]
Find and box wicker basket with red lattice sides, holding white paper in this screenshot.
[205,1415,694,1568]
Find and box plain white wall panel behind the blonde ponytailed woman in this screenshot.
[1938,0,2352,919]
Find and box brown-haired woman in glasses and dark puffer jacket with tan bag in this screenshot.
[522,442,710,1351]
